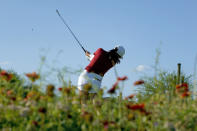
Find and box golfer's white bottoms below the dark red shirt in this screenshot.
[78,70,103,93]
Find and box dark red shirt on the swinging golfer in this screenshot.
[85,48,113,75]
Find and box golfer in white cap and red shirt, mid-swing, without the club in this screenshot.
[78,46,125,94]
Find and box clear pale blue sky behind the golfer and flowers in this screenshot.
[0,0,197,95]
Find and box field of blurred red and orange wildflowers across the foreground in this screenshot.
[0,64,197,131]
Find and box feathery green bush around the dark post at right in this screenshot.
[137,71,192,99]
